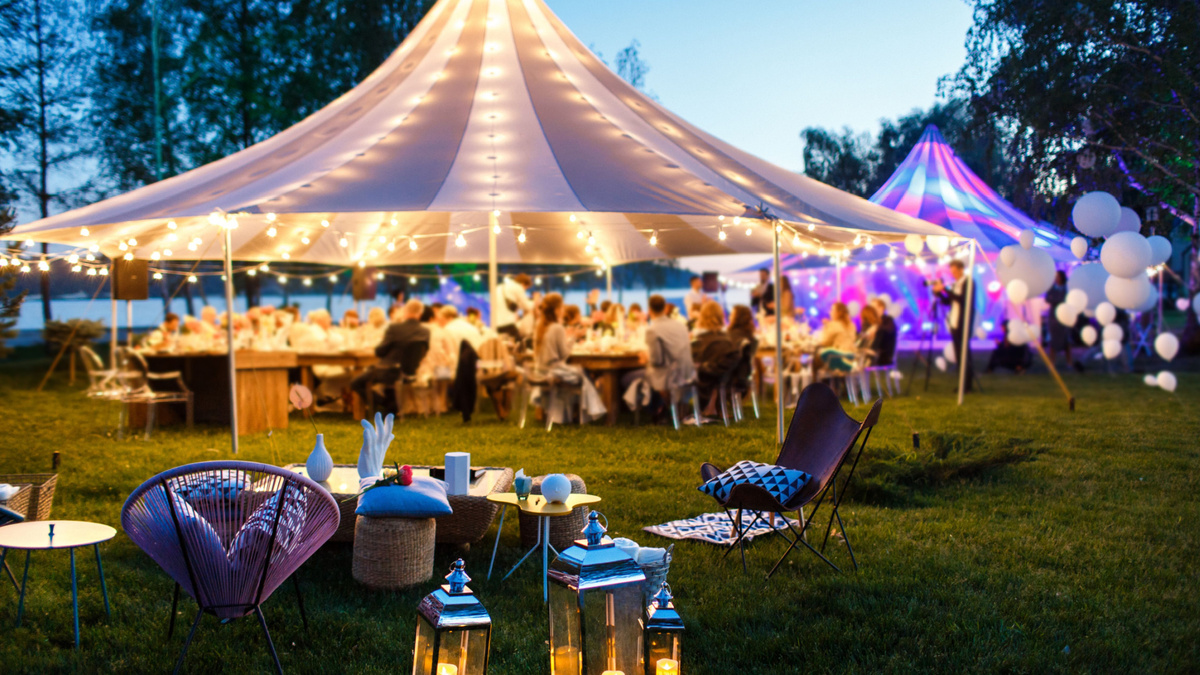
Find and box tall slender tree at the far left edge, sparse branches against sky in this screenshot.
[0,0,89,321]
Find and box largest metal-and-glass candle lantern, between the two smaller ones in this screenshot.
[550,512,646,675]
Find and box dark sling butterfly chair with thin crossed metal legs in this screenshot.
[700,383,883,579]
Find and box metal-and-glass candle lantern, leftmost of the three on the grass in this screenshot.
[413,558,492,675]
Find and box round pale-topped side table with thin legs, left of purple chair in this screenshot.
[0,520,116,649]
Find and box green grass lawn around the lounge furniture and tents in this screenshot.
[0,348,1200,674]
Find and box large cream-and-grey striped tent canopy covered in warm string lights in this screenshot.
[13,0,947,267]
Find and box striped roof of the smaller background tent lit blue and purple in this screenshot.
[871,125,1074,261]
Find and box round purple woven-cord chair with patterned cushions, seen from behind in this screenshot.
[121,461,338,673]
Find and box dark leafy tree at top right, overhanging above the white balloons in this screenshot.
[952,0,1200,228]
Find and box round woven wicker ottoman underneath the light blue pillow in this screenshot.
[352,515,437,590]
